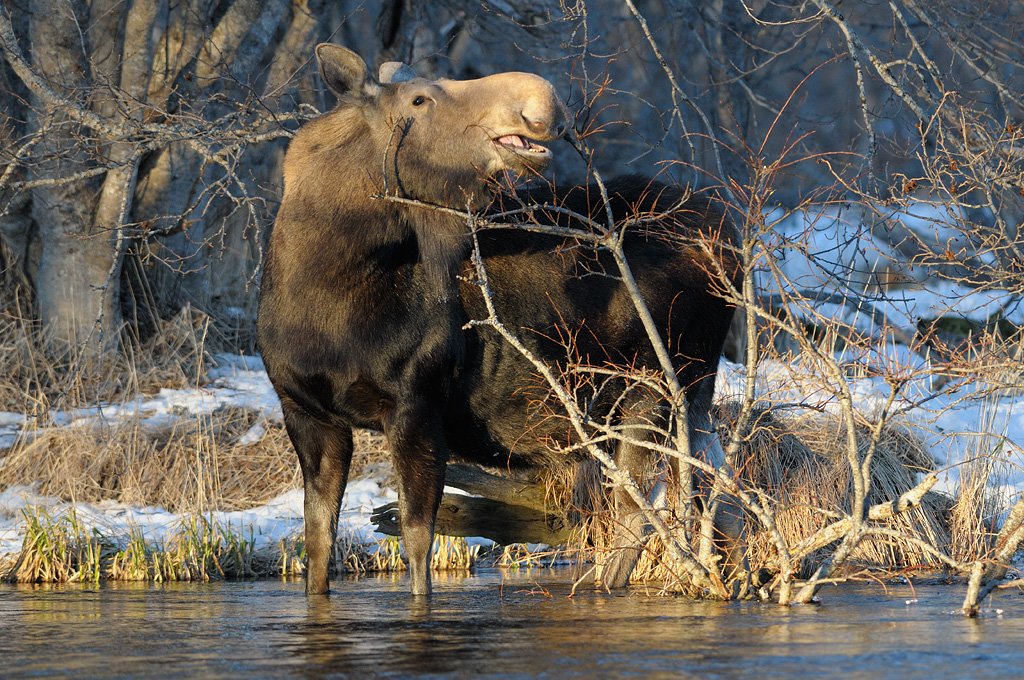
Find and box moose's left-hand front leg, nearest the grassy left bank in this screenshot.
[283,402,352,595]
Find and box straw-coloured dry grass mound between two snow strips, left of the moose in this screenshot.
[0,408,390,512]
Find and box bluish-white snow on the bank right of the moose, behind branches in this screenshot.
[749,202,1024,501]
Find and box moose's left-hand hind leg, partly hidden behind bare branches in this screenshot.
[601,409,651,589]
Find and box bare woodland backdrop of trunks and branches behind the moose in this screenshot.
[0,0,1024,346]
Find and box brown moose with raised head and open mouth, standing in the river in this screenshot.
[257,43,739,595]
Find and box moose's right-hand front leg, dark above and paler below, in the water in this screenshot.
[385,409,447,595]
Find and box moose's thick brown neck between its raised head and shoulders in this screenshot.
[279,111,483,300]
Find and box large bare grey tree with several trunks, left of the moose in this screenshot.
[0,0,319,349]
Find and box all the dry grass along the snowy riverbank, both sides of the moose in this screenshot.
[0,282,991,581]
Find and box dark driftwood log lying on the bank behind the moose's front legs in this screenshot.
[370,464,571,545]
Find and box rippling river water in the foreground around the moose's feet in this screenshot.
[0,570,1024,678]
